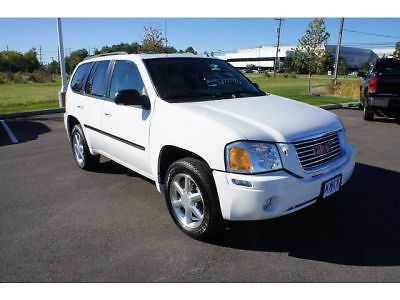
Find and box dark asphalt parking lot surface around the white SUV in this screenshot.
[0,109,400,282]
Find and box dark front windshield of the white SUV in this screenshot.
[144,58,265,102]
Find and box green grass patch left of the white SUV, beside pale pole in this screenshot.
[0,81,60,114]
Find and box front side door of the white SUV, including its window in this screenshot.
[102,60,151,175]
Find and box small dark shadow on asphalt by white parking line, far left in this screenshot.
[0,118,51,146]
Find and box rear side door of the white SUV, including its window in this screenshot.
[80,60,110,150]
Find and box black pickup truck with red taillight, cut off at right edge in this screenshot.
[359,58,400,121]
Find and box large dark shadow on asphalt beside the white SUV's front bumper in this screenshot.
[211,163,400,266]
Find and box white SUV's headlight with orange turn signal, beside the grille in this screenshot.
[225,141,282,174]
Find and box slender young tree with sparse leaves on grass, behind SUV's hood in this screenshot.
[298,18,330,94]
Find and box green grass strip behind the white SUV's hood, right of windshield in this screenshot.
[246,74,356,105]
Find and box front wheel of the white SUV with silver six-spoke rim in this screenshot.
[165,158,224,240]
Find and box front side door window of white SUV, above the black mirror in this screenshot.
[110,60,144,99]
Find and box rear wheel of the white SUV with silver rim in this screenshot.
[71,124,100,170]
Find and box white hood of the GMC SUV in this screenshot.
[179,95,342,142]
